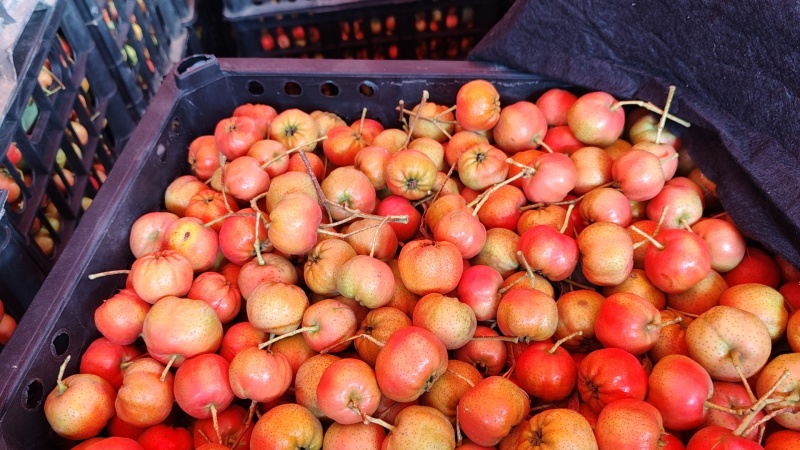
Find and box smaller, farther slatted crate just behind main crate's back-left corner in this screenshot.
[76,0,195,120]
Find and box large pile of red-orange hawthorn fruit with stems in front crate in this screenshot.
[44,80,800,450]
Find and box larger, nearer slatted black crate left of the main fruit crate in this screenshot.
[0,0,135,274]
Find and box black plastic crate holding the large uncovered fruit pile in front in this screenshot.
[0,56,563,449]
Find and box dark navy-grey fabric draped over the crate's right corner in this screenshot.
[469,0,800,267]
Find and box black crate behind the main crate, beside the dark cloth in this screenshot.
[224,0,507,60]
